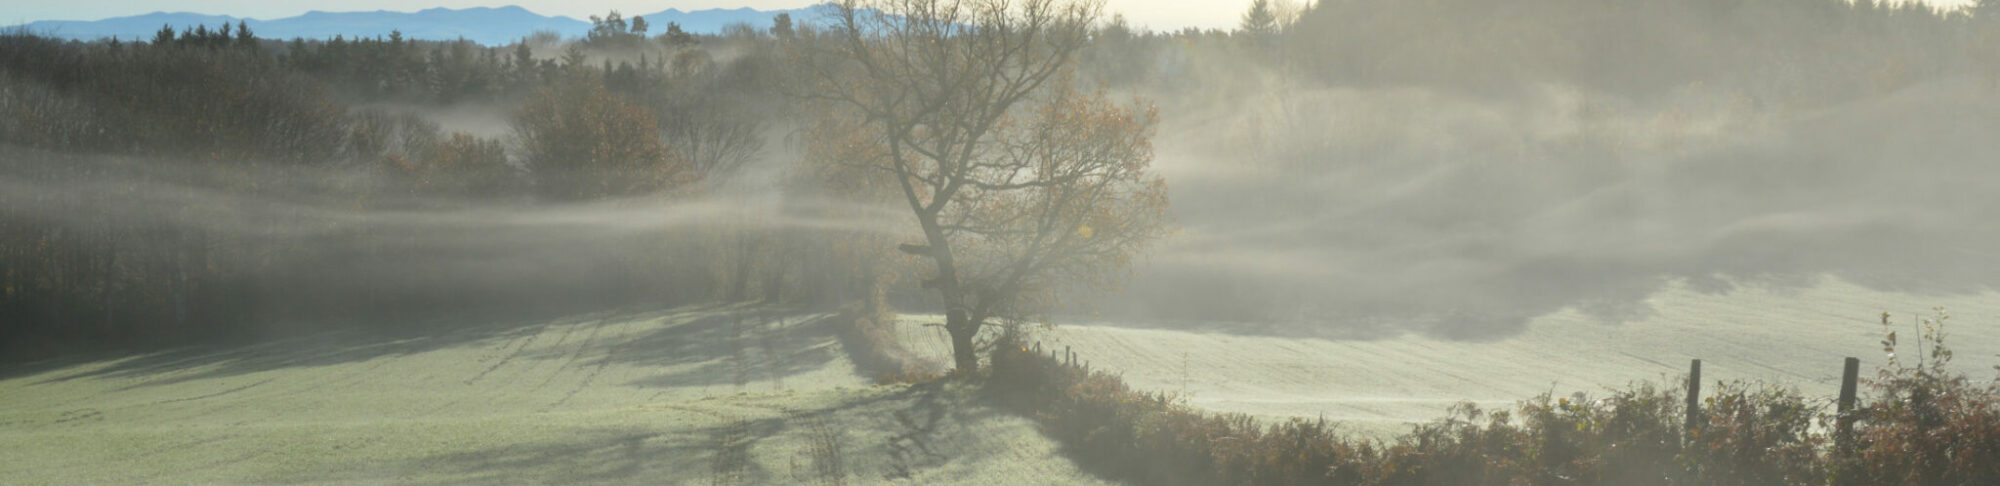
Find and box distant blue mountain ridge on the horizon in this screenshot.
[12,6,814,46]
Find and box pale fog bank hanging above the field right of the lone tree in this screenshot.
[1106,76,2000,340]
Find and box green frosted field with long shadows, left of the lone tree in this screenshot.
[0,308,1094,484]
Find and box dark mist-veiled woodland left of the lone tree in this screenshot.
[0,15,868,360]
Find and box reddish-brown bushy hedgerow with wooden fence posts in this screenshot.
[986,314,2000,486]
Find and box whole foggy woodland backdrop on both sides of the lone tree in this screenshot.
[15,0,2000,350]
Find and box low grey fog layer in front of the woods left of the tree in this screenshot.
[0,146,902,346]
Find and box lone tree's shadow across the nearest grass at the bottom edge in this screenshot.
[250,380,1104,484]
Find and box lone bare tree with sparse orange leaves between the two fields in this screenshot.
[790,0,1166,370]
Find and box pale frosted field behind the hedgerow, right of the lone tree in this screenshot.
[902,280,2000,436]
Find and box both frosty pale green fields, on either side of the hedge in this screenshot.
[0,274,2000,484]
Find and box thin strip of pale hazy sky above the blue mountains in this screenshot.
[0,0,1296,28]
